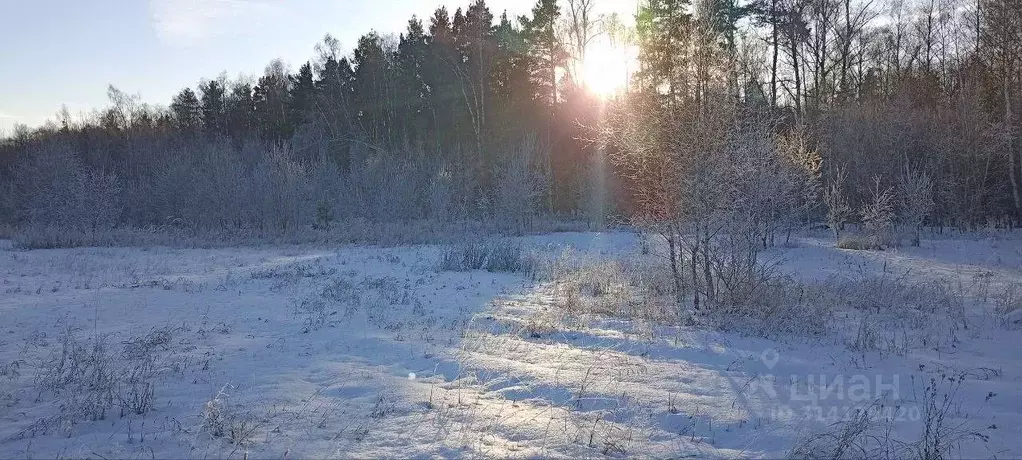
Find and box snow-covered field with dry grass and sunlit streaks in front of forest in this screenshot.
[0,232,1022,458]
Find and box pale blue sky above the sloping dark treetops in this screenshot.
[0,0,635,133]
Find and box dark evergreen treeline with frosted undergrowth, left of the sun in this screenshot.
[0,0,597,237]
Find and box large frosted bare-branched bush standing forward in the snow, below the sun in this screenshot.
[603,93,822,311]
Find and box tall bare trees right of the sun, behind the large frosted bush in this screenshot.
[623,0,1022,229]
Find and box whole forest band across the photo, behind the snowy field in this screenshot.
[0,0,1022,248]
